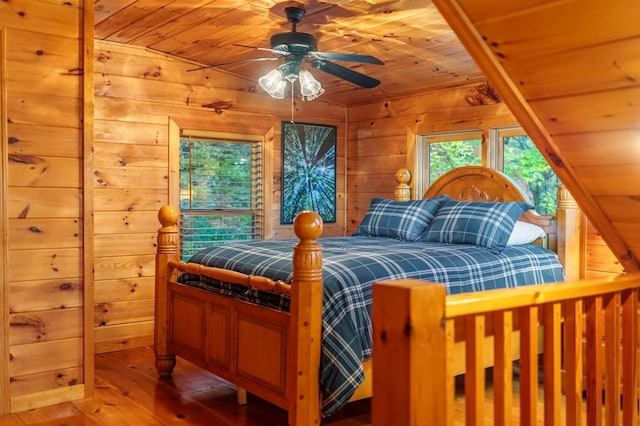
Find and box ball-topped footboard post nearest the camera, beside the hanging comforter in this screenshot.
[287,211,322,426]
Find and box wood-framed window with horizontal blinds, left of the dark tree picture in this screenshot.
[169,122,272,260]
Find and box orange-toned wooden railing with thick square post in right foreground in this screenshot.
[372,274,640,426]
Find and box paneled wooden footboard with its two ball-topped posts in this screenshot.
[154,206,322,425]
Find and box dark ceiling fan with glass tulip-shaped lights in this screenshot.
[189,7,384,92]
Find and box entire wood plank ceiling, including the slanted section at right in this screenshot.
[95,0,640,271]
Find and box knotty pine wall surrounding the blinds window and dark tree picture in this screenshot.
[92,41,346,353]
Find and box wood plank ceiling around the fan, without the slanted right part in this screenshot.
[95,0,486,105]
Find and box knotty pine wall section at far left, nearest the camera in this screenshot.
[0,0,93,414]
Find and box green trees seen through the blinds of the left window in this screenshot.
[180,138,262,260]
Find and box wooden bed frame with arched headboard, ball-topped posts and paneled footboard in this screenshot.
[154,166,582,426]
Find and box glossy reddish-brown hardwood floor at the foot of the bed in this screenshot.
[0,348,371,426]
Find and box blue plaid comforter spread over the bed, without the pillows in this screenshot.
[180,236,564,416]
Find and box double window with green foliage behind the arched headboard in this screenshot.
[413,127,560,215]
